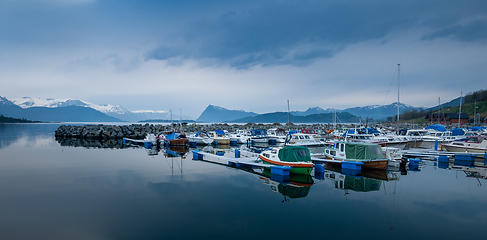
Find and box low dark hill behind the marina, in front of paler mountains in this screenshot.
[227,112,360,123]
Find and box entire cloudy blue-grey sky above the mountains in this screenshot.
[0,0,487,117]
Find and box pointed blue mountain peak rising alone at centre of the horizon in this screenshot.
[196,105,257,122]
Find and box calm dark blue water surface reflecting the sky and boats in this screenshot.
[0,124,487,239]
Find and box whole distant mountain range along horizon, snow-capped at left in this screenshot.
[0,96,428,123]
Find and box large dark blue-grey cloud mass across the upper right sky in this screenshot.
[145,1,486,69]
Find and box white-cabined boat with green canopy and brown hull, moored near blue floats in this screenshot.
[323,141,389,170]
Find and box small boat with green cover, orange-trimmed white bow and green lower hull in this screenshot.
[259,146,313,175]
